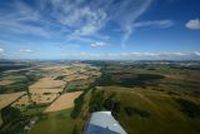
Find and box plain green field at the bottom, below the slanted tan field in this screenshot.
[31,109,72,134]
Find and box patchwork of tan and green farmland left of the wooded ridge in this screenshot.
[0,62,101,134]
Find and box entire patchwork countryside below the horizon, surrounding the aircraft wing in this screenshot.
[0,61,200,134]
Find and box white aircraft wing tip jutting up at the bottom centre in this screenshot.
[85,111,127,134]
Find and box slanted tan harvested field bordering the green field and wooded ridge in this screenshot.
[45,91,82,112]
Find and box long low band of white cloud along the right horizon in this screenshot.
[61,52,200,60]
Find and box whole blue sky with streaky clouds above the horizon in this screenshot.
[0,0,200,60]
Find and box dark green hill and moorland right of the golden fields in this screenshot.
[72,64,200,134]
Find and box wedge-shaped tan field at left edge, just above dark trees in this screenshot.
[0,92,26,109]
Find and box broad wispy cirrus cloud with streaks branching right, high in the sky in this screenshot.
[0,0,172,46]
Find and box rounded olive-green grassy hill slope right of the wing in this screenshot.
[100,87,200,134]
